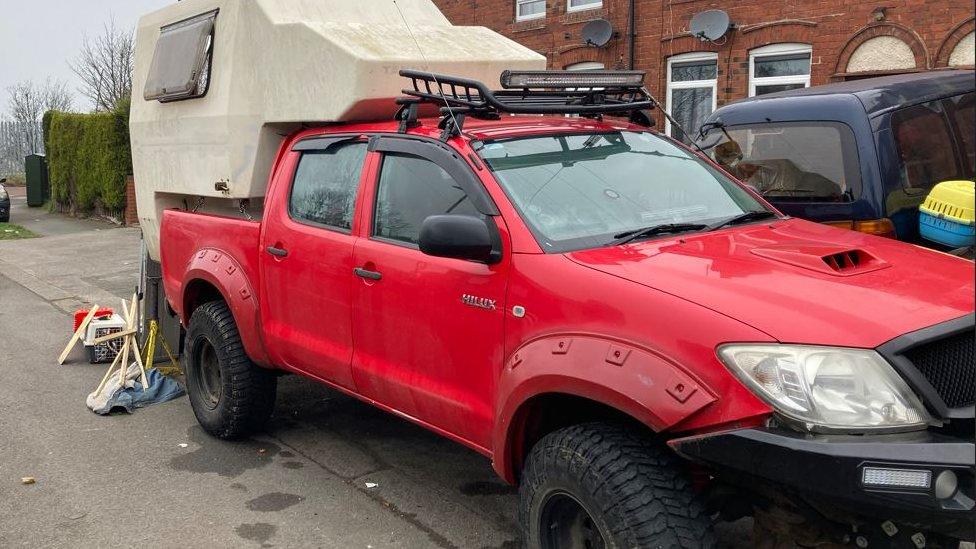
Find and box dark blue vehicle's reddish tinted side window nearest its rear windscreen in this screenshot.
[891,101,959,189]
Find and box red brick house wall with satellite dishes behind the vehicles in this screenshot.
[434,0,973,122]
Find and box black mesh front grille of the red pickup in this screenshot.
[905,331,976,408]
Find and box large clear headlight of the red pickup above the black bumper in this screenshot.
[718,344,931,431]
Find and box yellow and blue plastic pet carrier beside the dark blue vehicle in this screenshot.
[918,181,976,248]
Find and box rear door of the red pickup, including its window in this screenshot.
[260,136,367,389]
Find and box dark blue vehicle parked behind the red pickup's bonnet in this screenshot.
[697,70,976,242]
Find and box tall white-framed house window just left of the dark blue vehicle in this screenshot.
[665,53,718,144]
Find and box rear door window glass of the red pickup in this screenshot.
[288,142,366,230]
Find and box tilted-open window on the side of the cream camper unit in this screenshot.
[143,10,217,102]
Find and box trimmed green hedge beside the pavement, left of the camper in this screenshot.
[43,103,132,212]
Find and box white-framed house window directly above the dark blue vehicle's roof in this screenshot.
[749,44,812,97]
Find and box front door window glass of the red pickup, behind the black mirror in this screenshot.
[373,154,481,244]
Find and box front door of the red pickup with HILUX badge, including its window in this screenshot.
[352,138,510,447]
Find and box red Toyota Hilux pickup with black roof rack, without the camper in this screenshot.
[161,71,976,547]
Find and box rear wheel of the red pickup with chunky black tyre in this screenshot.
[185,301,278,438]
